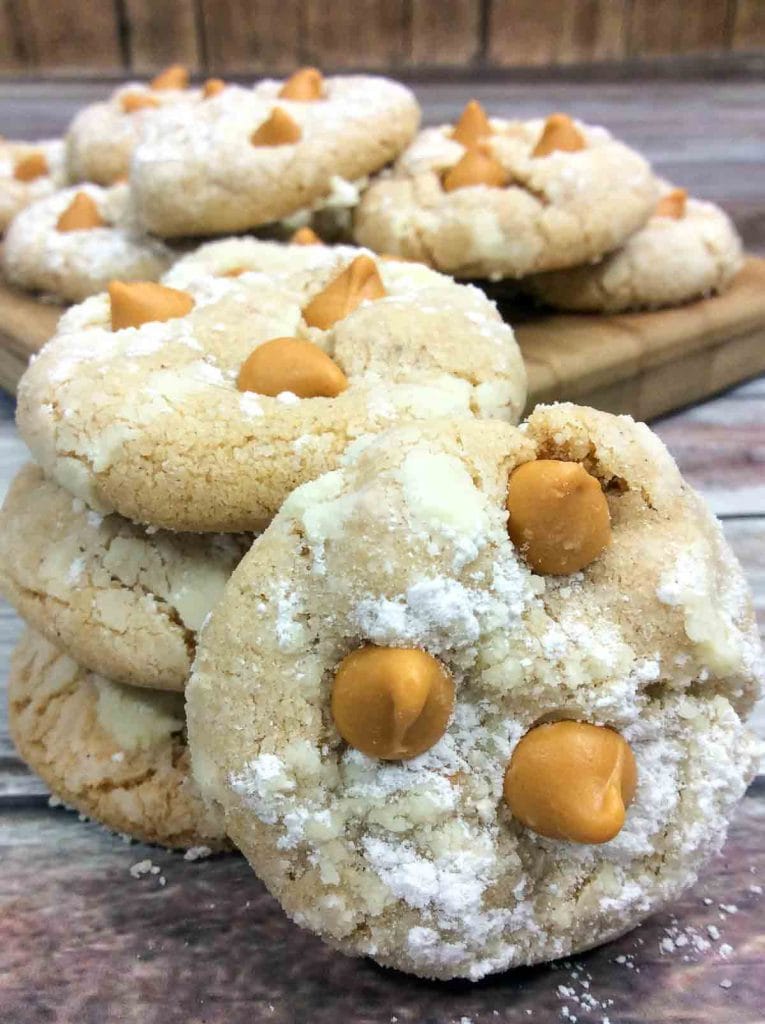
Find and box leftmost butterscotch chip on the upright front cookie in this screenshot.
[332,646,455,761]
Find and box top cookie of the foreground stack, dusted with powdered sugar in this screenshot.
[17,243,525,532]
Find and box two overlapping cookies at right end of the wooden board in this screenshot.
[354,100,742,313]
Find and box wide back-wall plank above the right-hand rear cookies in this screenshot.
[487,0,628,67]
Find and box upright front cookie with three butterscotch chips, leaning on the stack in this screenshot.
[186,404,760,979]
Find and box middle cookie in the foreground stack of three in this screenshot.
[0,464,249,690]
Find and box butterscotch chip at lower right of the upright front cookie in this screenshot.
[504,721,637,844]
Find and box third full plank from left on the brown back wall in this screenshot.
[200,0,301,76]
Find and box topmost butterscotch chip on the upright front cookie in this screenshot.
[507,459,611,575]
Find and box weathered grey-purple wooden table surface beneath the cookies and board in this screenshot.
[0,81,765,1024]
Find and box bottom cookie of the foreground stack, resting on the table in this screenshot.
[8,632,228,850]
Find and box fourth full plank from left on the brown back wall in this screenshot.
[303,0,407,70]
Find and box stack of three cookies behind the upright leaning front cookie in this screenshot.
[0,220,525,849]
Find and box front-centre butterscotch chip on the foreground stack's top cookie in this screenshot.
[237,338,348,398]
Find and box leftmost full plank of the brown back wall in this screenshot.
[15,0,123,74]
